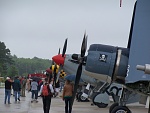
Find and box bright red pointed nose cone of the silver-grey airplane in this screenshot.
[52,54,65,65]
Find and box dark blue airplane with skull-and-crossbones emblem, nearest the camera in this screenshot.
[68,0,150,113]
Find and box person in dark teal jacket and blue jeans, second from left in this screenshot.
[13,77,21,102]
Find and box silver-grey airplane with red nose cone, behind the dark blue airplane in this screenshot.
[51,39,125,108]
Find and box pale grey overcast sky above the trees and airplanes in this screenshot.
[0,0,135,59]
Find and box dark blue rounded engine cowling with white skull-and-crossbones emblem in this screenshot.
[85,44,129,83]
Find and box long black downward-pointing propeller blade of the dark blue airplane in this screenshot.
[72,63,82,106]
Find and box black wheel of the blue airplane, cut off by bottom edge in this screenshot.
[111,106,131,113]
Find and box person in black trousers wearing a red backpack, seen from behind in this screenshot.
[40,78,54,113]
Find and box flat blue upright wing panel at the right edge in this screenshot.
[126,0,150,83]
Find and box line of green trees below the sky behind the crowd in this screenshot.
[0,41,51,77]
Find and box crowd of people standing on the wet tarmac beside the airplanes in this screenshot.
[4,76,73,113]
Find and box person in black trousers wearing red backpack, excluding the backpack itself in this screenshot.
[40,78,54,113]
